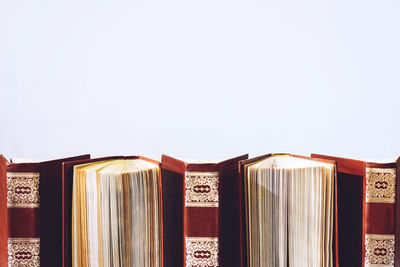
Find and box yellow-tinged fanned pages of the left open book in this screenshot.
[72,159,162,267]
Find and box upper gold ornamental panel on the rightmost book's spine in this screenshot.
[365,168,396,203]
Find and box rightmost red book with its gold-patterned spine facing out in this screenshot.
[311,154,400,267]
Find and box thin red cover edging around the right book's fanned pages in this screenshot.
[238,153,340,267]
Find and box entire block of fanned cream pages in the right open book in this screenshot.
[244,156,334,267]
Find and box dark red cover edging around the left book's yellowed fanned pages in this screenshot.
[59,156,164,267]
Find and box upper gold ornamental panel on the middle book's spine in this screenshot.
[185,172,219,207]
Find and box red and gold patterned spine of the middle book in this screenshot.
[183,172,220,267]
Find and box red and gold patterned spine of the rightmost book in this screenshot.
[363,166,398,267]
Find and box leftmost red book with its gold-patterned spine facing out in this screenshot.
[0,155,90,267]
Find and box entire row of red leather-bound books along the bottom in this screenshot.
[0,154,400,267]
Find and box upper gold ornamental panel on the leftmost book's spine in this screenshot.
[7,172,40,208]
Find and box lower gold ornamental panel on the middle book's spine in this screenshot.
[185,237,219,267]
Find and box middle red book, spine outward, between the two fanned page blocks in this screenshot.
[161,155,248,267]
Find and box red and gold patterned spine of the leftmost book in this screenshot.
[6,171,40,267]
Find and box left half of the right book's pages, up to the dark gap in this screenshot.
[249,167,287,267]
